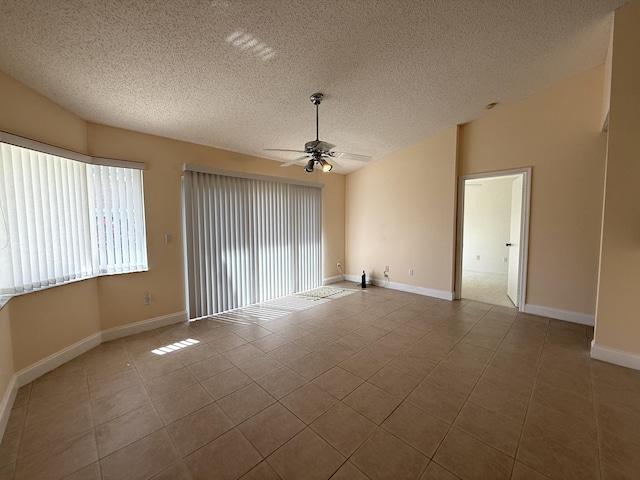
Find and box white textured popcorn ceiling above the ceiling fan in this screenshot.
[0,0,626,173]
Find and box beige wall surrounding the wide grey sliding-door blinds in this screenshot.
[88,124,344,329]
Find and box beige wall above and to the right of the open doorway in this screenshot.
[458,67,606,315]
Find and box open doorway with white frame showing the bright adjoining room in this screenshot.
[456,168,531,311]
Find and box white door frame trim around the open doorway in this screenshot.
[454,167,531,312]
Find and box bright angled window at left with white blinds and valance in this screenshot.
[0,133,148,296]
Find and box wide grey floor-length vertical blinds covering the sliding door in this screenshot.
[184,169,322,319]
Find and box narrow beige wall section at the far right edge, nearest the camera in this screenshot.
[595,1,640,355]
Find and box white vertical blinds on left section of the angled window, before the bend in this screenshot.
[0,143,97,294]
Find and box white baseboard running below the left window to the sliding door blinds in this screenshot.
[16,311,187,387]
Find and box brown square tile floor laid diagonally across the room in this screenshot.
[0,288,640,480]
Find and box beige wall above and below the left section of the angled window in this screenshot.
[0,72,100,372]
